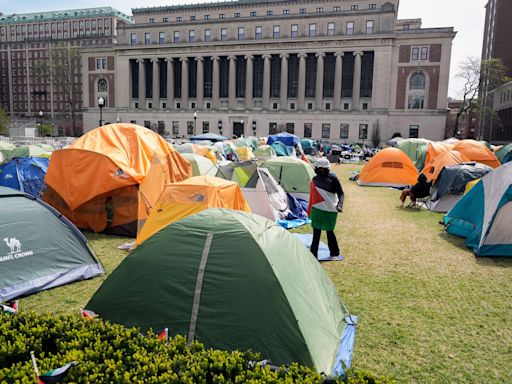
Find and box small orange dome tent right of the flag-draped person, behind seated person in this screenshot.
[357,147,419,187]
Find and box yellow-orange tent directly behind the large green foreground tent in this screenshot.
[136,176,251,244]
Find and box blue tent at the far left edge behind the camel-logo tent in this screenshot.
[0,157,49,197]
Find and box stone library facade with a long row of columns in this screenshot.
[82,0,455,144]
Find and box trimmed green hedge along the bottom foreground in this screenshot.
[0,312,394,384]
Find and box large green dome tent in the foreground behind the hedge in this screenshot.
[86,209,355,374]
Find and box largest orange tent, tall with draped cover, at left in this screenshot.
[44,124,192,236]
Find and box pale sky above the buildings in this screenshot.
[0,0,487,98]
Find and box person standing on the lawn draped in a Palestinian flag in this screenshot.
[308,157,345,259]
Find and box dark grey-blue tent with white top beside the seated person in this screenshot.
[427,163,492,212]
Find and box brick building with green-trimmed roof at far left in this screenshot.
[0,7,132,135]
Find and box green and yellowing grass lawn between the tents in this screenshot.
[17,165,512,383]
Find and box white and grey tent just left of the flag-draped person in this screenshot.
[242,168,290,222]
